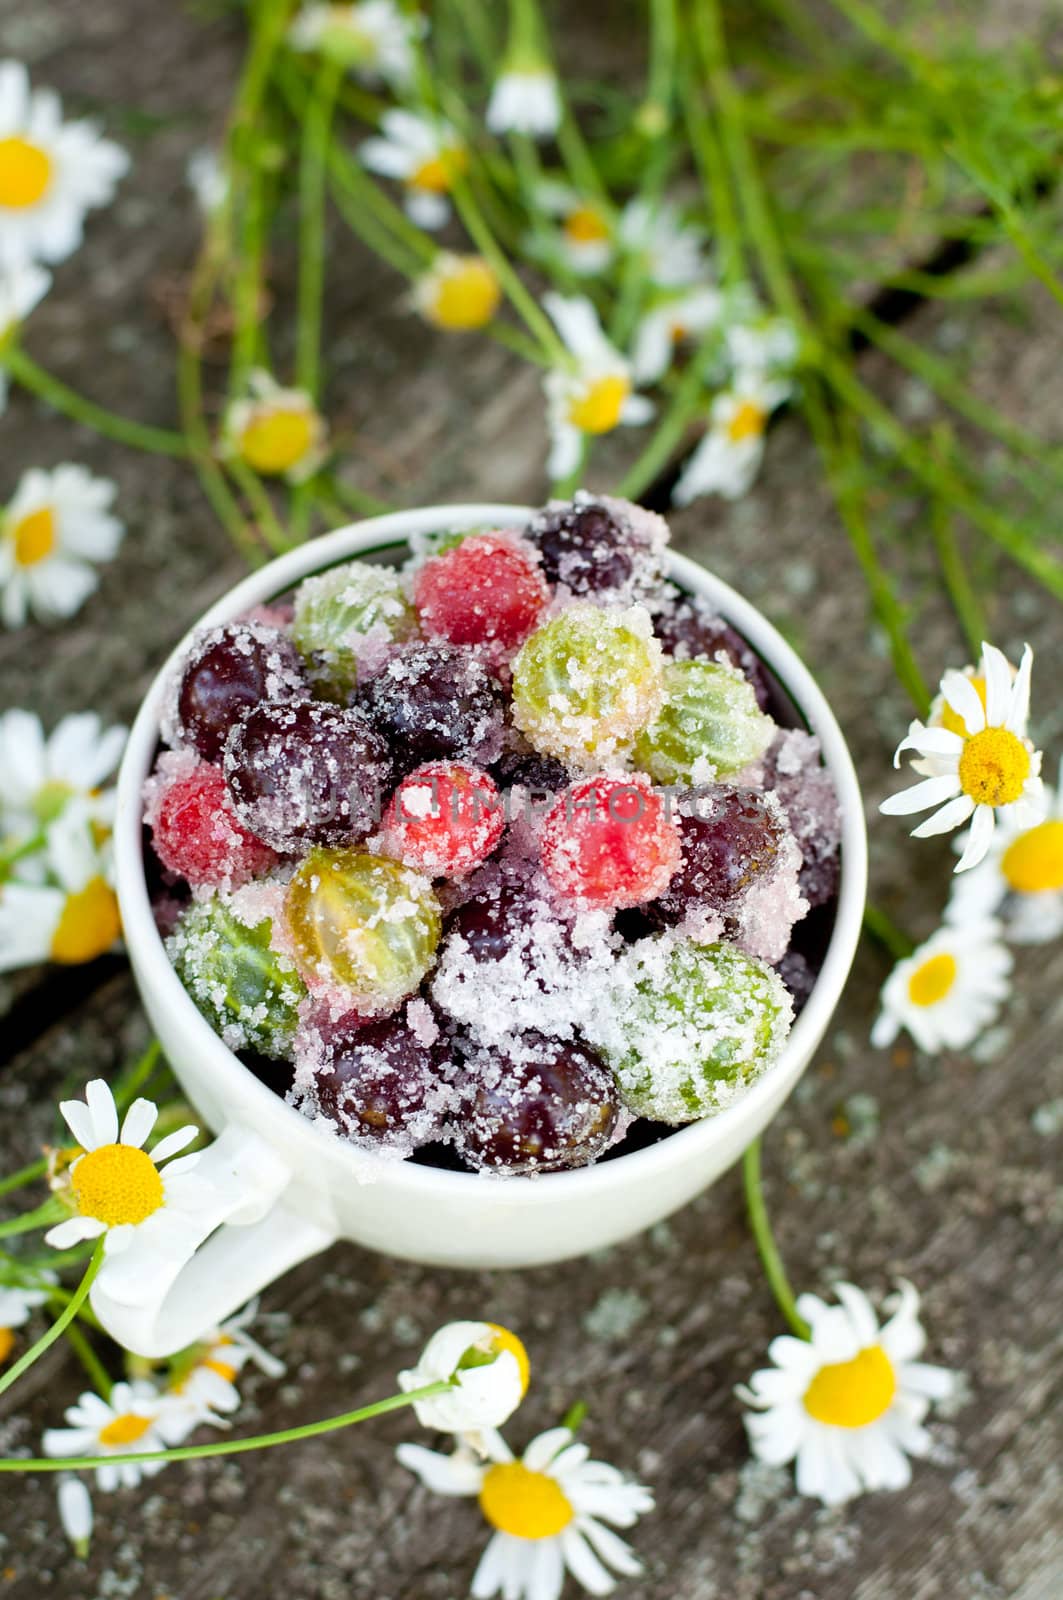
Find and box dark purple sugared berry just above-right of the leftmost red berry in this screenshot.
[224,699,391,851]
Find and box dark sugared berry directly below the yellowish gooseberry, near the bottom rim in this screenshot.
[288,1014,453,1155]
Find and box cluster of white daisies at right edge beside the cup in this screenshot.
[871,643,1063,1053]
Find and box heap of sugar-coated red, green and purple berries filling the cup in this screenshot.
[144,494,840,1174]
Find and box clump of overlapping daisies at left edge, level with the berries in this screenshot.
[0,710,126,971]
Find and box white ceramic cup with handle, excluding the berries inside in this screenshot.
[101,506,866,1357]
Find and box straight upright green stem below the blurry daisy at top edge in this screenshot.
[295,58,343,402]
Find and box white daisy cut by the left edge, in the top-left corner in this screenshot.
[0,61,130,269]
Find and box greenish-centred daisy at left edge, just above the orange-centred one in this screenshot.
[0,709,128,834]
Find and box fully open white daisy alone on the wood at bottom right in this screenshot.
[738,1283,956,1506]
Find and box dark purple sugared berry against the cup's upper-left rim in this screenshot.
[171,622,307,762]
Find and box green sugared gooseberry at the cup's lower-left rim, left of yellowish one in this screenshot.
[166,886,306,1056]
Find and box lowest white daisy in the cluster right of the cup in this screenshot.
[871,918,1012,1054]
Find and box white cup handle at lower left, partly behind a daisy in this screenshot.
[90,1125,336,1360]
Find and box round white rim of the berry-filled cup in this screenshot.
[114,502,868,1205]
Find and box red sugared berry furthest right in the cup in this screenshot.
[541,773,680,909]
